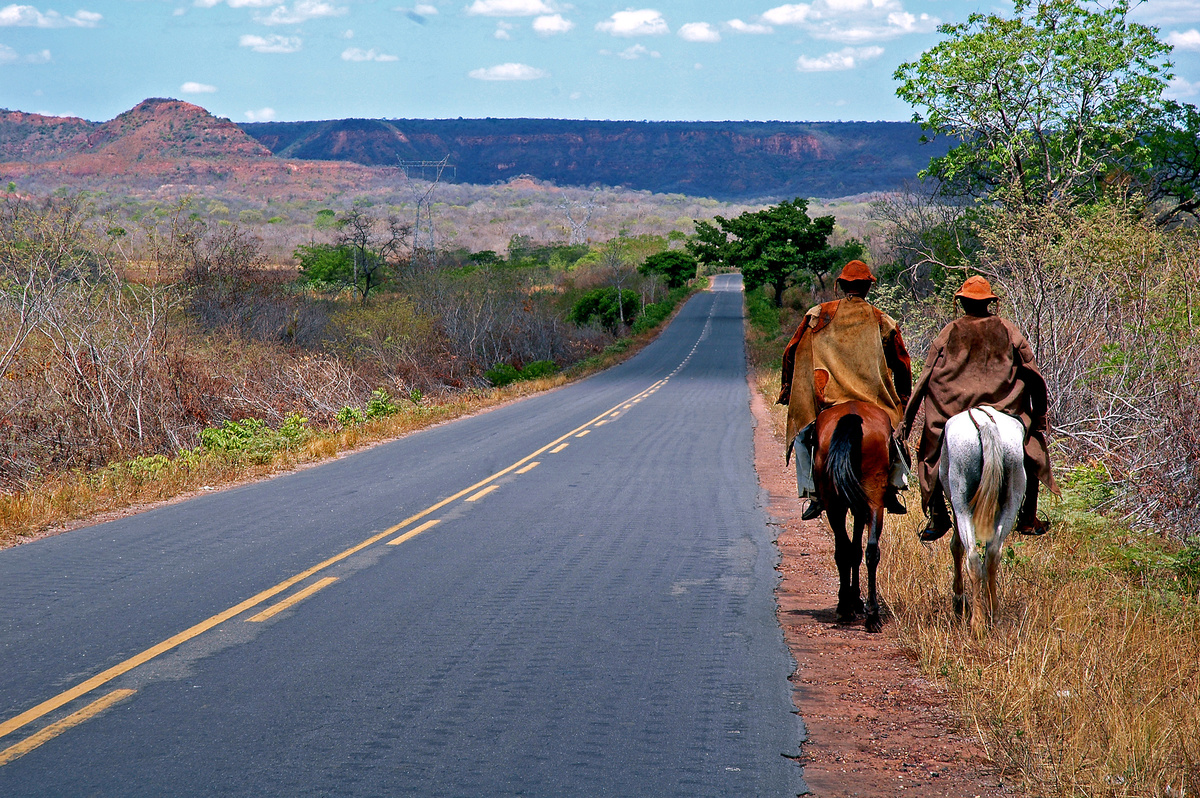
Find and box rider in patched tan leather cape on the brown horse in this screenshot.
[776,260,912,521]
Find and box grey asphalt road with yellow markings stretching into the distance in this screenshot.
[0,275,805,798]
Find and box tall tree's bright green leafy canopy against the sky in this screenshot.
[895,0,1171,204]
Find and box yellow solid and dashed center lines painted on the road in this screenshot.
[0,379,667,767]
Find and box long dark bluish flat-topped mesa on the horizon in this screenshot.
[241,119,946,200]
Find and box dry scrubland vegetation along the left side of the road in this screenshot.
[0,184,696,541]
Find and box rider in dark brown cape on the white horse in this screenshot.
[899,276,1058,541]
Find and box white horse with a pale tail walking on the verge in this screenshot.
[940,407,1026,623]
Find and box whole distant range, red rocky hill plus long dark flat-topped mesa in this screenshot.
[0,98,946,200]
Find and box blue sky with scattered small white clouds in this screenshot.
[0,0,1200,121]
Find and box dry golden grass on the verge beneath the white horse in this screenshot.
[756,360,1200,798]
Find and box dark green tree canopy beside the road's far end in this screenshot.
[688,197,840,306]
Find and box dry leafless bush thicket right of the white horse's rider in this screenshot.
[978,205,1200,539]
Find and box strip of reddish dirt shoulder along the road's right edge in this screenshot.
[750,380,1006,798]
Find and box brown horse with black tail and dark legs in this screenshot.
[812,401,892,632]
